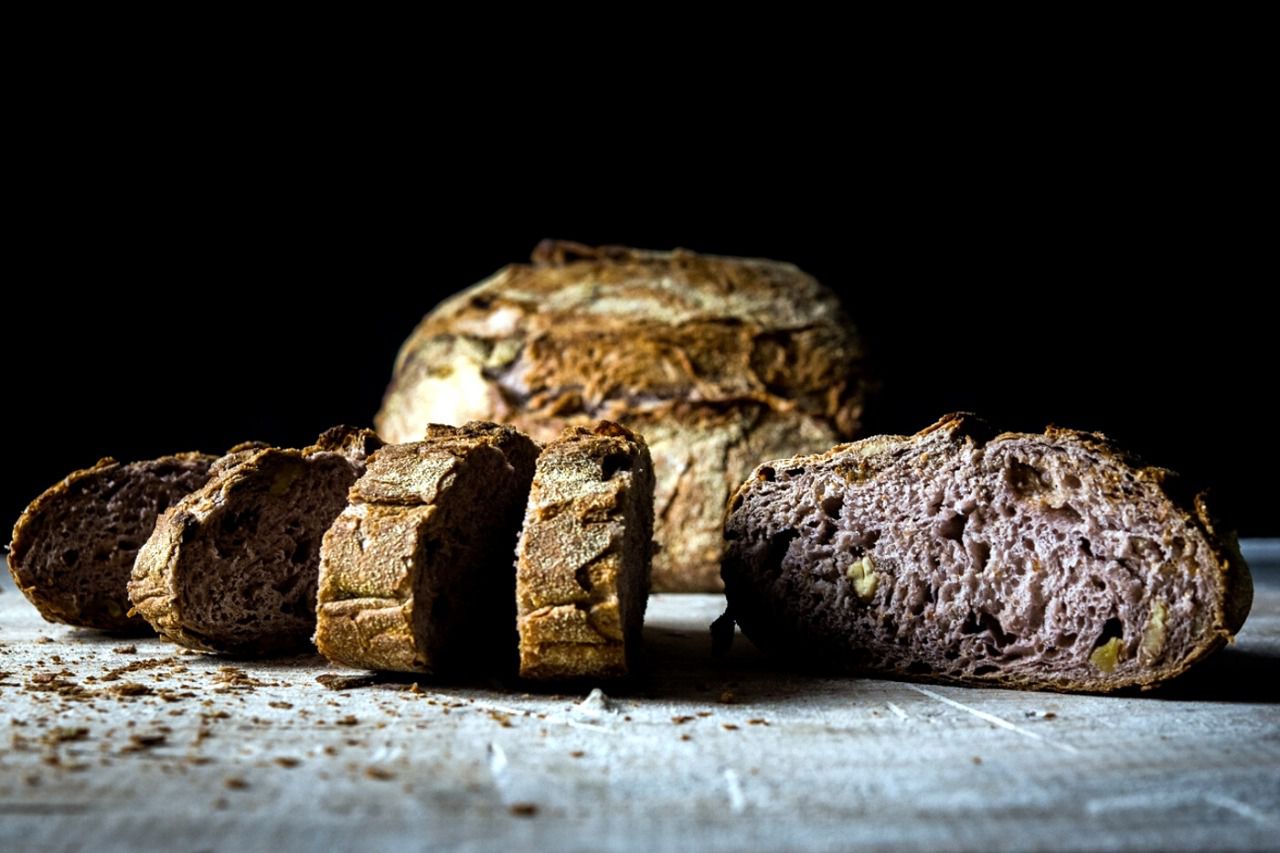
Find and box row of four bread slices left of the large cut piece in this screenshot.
[9,421,654,680]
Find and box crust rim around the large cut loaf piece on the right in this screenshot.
[723,412,1253,693]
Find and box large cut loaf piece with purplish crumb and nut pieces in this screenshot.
[722,415,1253,692]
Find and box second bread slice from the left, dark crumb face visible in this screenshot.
[129,427,380,654]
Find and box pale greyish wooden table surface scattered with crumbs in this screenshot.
[0,540,1280,853]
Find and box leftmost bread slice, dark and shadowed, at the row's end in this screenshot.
[9,453,218,631]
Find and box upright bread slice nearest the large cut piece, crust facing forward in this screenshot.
[516,421,654,679]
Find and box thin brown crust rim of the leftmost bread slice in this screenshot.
[8,452,216,631]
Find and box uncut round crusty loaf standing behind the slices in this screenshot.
[378,235,864,590]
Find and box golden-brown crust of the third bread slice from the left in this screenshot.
[315,423,538,672]
